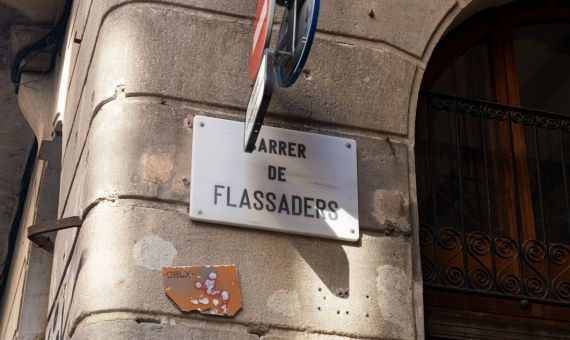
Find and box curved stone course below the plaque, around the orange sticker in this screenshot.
[63,203,414,338]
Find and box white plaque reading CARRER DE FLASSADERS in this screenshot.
[190,116,359,241]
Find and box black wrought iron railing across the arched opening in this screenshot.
[416,94,570,306]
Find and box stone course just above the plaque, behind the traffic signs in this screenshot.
[81,4,415,135]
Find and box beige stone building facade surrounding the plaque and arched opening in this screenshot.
[0,0,568,339]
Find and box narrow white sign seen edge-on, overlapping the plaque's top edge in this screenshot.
[244,49,275,152]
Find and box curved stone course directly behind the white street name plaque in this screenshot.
[74,99,410,232]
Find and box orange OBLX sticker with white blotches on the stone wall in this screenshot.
[162,266,241,316]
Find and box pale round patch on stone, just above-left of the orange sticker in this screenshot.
[133,235,178,270]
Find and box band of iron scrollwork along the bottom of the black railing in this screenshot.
[420,226,570,304]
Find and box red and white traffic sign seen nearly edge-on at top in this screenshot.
[249,0,275,81]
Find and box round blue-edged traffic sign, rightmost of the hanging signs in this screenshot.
[275,0,320,87]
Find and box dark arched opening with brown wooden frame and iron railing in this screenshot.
[415,1,570,337]
